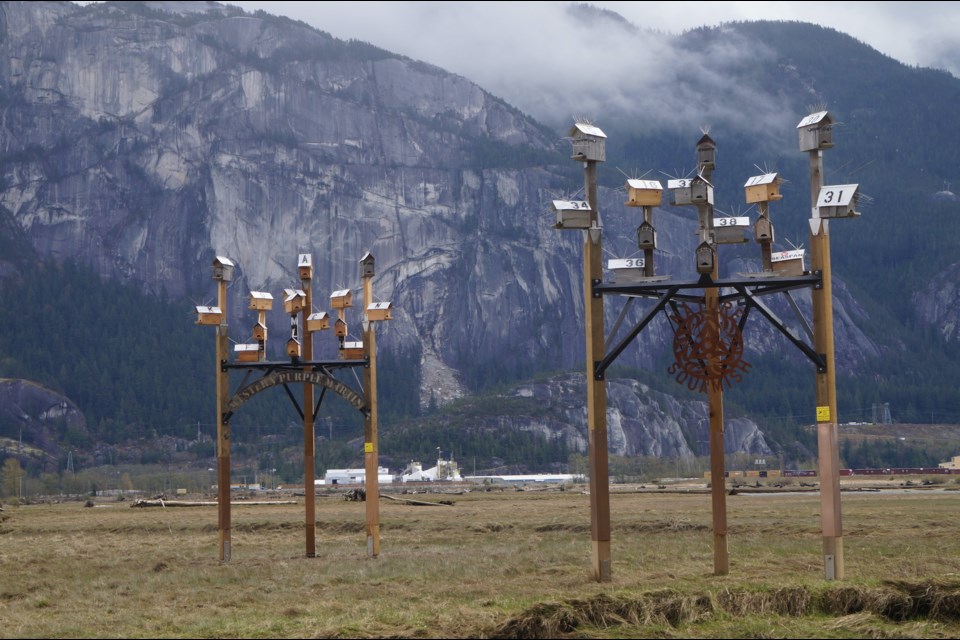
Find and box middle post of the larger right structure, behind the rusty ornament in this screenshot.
[697,135,730,576]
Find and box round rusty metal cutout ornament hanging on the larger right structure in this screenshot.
[667,302,751,393]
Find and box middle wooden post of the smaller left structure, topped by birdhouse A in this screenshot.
[298,254,317,558]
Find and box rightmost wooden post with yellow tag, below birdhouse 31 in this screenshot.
[810,149,844,580]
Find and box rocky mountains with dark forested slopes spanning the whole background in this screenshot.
[0,2,960,476]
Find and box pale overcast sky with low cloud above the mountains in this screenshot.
[221,1,960,131]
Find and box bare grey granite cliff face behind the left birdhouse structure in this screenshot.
[0,2,879,455]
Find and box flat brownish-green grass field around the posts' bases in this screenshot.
[0,485,960,638]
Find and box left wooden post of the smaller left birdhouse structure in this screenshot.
[216,280,230,562]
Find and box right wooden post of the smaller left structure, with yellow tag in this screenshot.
[361,254,380,558]
